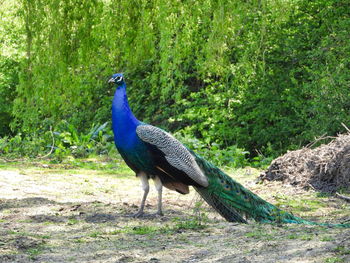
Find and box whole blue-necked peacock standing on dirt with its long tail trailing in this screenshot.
[108,73,350,227]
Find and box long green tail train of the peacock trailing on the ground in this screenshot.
[192,152,350,227]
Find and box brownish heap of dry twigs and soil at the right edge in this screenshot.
[261,133,350,193]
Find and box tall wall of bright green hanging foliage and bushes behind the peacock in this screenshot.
[0,0,350,160]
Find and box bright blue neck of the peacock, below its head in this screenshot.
[112,82,140,148]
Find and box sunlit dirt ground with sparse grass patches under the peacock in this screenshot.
[0,164,350,263]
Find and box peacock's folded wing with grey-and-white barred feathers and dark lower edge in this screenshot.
[136,125,208,187]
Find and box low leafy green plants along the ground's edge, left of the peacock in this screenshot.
[0,121,115,161]
